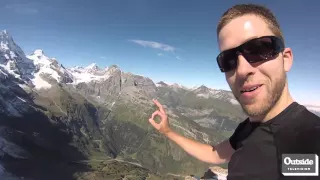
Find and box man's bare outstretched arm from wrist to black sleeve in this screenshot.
[165,131,234,164]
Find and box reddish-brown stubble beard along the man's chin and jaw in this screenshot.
[236,72,287,117]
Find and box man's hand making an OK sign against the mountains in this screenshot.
[149,99,171,134]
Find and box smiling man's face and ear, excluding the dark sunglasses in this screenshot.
[219,15,292,117]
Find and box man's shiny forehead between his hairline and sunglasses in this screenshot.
[218,15,273,51]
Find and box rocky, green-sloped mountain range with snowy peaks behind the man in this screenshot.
[0,31,245,180]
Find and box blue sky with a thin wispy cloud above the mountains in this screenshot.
[0,0,320,104]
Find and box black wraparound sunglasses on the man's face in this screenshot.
[217,36,284,72]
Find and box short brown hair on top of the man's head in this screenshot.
[217,4,284,42]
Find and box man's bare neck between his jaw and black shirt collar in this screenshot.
[249,85,294,122]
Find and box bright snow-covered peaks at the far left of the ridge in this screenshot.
[0,31,126,93]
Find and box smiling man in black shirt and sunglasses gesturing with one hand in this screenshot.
[149,4,320,180]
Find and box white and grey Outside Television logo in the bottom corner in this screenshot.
[282,154,319,176]
